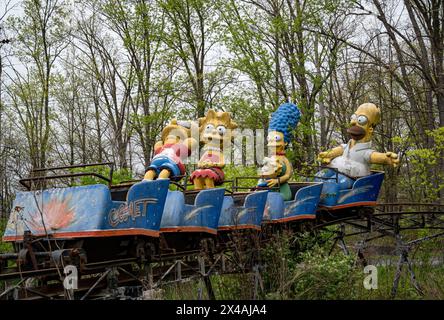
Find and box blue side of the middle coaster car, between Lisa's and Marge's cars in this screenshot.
[219,190,268,227]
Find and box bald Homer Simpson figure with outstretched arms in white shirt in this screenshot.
[317,103,399,189]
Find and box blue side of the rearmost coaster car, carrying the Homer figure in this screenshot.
[320,172,384,208]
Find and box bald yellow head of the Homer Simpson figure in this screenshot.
[347,103,380,142]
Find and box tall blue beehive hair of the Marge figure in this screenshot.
[268,102,301,143]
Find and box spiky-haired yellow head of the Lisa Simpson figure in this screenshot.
[199,109,237,145]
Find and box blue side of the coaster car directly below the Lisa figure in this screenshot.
[160,188,225,230]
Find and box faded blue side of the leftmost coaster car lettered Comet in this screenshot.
[4,180,169,238]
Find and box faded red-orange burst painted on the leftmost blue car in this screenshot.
[29,198,75,231]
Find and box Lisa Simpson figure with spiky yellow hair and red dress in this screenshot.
[190,109,237,189]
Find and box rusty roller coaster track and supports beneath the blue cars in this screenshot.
[0,202,444,299]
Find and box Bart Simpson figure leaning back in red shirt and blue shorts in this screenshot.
[144,119,197,180]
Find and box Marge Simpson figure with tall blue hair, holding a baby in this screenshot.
[258,103,301,201]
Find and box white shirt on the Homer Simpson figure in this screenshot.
[328,140,374,178]
